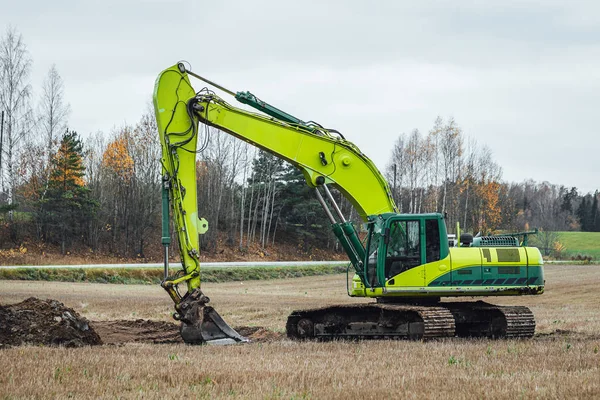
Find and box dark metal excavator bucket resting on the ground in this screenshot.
[178,289,249,345]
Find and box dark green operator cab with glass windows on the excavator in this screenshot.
[366,213,449,287]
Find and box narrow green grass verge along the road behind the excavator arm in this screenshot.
[0,265,346,284]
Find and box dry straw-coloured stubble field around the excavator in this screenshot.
[0,266,600,399]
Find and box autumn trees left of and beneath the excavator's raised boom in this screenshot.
[0,28,336,257]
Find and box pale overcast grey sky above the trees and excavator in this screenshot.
[0,0,600,193]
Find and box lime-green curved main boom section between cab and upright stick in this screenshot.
[195,90,396,221]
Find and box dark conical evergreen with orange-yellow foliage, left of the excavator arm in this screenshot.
[38,130,98,254]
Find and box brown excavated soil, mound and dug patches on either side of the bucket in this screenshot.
[0,297,285,349]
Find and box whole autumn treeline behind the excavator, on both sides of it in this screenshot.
[0,29,600,257]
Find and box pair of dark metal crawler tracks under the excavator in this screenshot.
[286,302,535,340]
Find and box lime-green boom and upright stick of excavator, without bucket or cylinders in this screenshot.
[154,65,396,296]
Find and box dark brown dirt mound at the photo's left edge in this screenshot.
[0,297,102,348]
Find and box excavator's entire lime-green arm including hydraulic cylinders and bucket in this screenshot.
[154,63,396,342]
